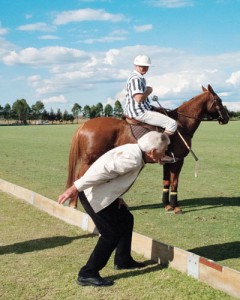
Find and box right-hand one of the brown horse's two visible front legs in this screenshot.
[170,160,184,214]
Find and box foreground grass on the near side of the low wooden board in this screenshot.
[0,192,234,300]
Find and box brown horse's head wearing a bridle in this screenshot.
[202,84,229,125]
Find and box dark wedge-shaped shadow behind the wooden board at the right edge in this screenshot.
[187,241,240,261]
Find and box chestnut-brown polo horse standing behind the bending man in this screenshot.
[67,85,229,214]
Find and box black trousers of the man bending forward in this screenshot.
[79,192,134,277]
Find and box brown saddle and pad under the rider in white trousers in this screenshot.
[123,116,164,140]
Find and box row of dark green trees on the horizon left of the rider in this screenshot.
[0,99,123,124]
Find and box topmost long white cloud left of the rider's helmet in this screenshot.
[53,8,124,25]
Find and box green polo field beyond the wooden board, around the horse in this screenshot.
[0,122,240,270]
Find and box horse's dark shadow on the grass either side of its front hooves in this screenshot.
[130,197,240,212]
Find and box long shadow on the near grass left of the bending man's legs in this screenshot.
[0,234,96,255]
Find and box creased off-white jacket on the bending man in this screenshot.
[74,144,145,213]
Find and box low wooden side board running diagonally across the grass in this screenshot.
[0,179,240,299]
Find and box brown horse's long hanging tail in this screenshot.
[66,126,82,188]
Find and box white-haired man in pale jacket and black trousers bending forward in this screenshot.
[58,131,170,286]
